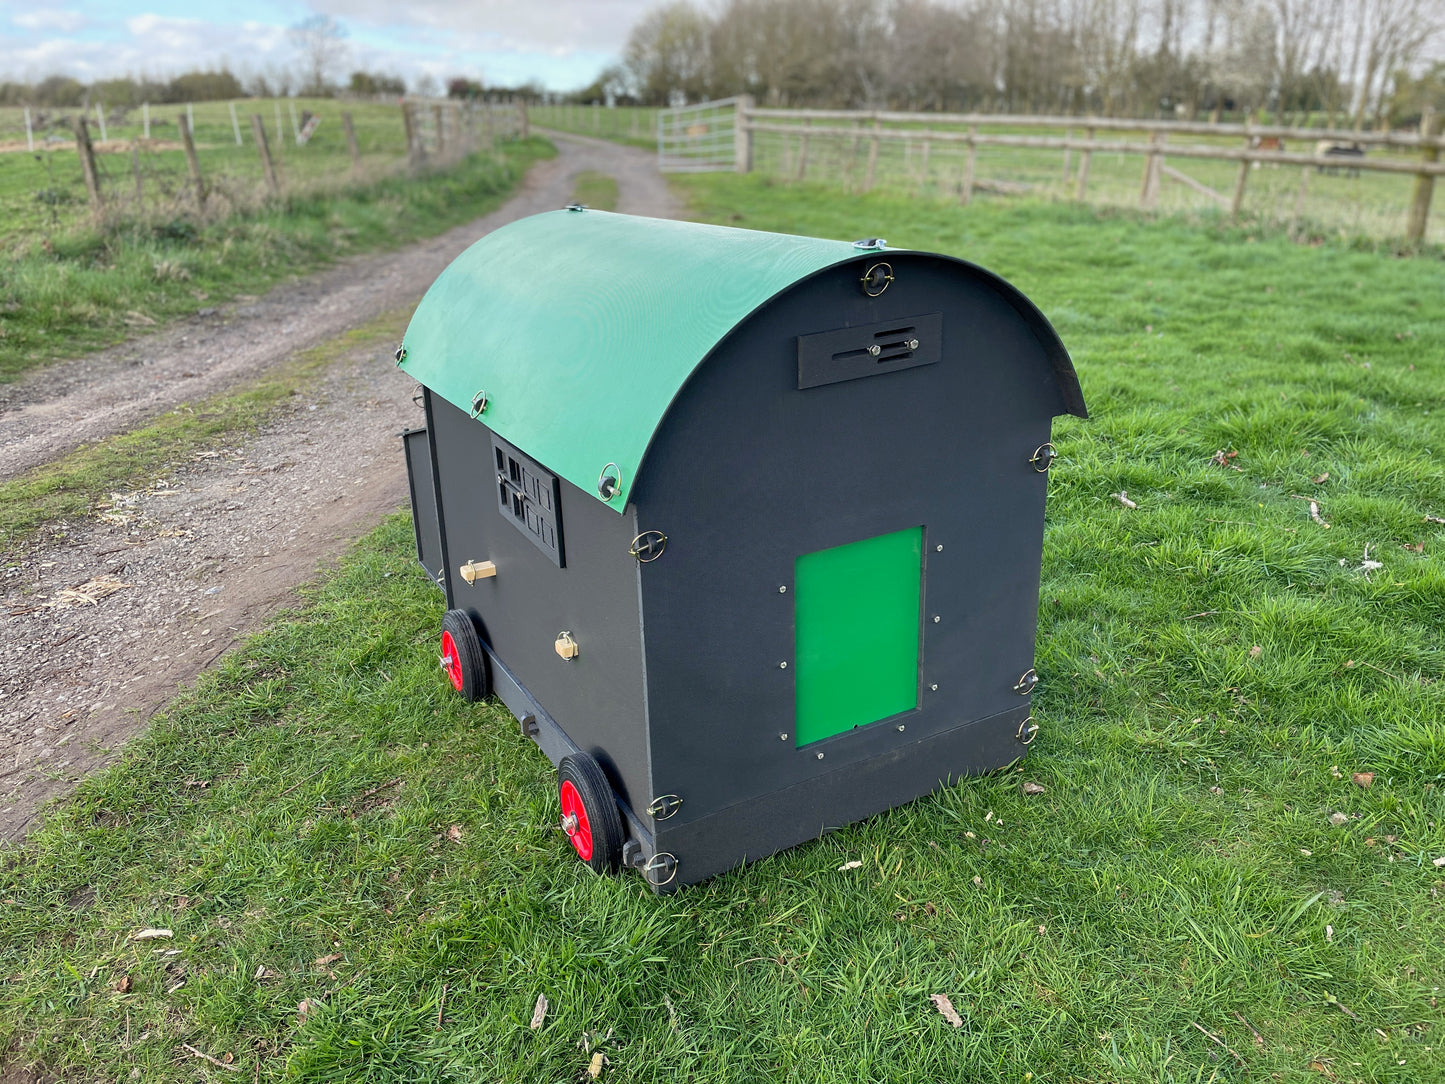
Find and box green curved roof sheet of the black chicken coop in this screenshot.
[402,211,863,512]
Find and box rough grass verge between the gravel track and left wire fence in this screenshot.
[0,140,553,382]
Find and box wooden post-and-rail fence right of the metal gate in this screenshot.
[728,97,1445,243]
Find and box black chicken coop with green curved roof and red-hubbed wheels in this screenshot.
[397,207,1085,890]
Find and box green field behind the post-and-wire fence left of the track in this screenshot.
[0,98,499,253]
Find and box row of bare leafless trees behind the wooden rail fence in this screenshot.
[606,0,1445,126]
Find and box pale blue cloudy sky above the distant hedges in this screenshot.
[0,0,656,91]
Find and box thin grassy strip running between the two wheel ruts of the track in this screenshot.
[0,306,412,562]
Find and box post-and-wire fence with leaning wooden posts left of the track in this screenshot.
[0,98,527,249]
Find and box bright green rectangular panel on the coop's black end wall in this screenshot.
[793,528,923,746]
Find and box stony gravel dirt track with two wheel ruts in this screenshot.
[0,133,678,841]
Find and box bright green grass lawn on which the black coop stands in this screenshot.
[0,176,1445,1084]
